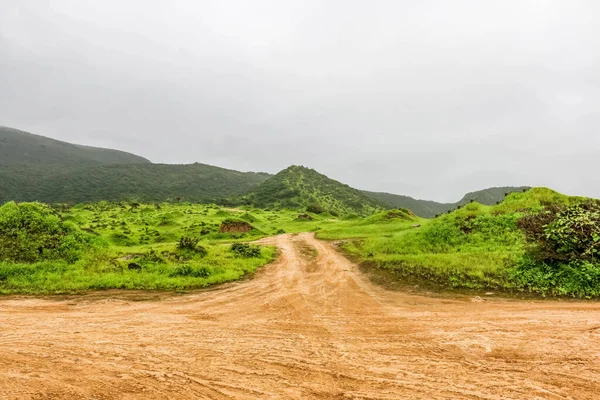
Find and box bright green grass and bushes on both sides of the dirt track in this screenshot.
[0,188,600,297]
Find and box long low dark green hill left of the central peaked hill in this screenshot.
[0,164,269,204]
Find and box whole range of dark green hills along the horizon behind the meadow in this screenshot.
[0,126,526,218]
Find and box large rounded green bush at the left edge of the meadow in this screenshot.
[0,202,90,263]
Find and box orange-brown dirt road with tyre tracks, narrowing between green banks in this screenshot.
[0,234,600,400]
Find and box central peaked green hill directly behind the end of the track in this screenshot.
[245,165,382,215]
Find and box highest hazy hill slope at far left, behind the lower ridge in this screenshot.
[0,126,150,165]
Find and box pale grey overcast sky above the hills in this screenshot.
[0,0,600,201]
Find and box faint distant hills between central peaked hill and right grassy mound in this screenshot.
[363,186,529,218]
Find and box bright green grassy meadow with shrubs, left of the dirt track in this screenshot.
[0,202,334,294]
